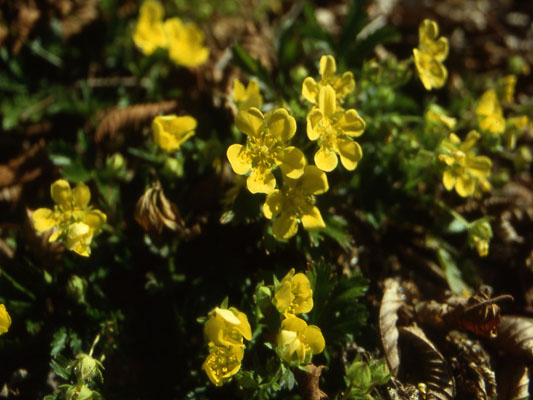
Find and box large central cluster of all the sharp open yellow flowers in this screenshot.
[226,55,365,239]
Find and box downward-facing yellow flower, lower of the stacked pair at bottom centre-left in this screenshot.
[202,342,244,386]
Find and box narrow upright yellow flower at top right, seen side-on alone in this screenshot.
[413,19,449,90]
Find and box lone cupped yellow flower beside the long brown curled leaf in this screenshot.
[152,115,197,152]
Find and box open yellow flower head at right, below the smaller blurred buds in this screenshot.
[439,131,492,197]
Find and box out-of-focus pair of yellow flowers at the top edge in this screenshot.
[133,0,209,67]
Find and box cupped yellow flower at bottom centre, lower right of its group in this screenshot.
[277,317,326,364]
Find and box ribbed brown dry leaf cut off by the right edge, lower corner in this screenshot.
[492,315,533,364]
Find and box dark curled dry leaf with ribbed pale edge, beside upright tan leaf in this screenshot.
[399,326,455,400]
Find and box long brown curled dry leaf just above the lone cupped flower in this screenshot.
[94,100,178,143]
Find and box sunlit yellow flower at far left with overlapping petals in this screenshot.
[32,179,107,257]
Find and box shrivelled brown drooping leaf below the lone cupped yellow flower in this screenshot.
[135,182,185,237]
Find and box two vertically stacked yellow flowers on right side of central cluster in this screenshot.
[302,56,365,172]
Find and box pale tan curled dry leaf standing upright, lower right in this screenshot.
[379,278,404,374]
